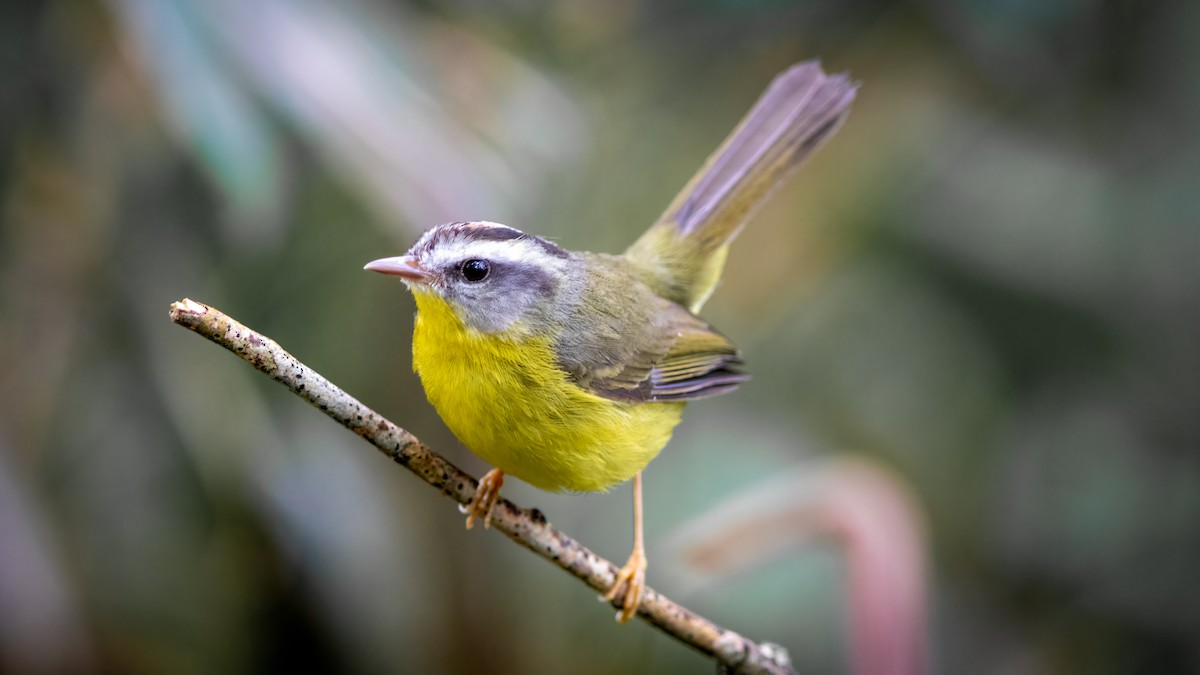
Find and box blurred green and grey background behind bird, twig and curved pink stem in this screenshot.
[0,0,1200,674]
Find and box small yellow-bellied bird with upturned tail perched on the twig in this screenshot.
[366,62,857,622]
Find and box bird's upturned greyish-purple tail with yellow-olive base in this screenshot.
[625,61,858,312]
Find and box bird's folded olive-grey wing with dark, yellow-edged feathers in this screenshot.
[557,260,749,402]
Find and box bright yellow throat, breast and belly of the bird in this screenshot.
[413,292,684,491]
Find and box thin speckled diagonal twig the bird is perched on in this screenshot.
[170,299,794,674]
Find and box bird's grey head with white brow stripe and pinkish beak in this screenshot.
[364,221,580,333]
